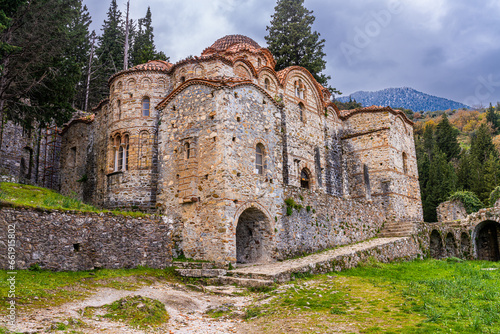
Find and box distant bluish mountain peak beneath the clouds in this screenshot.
[337,87,469,112]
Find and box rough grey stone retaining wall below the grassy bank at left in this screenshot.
[0,207,172,271]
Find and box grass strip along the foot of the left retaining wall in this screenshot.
[0,267,177,309]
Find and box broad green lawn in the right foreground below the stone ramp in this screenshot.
[246,260,500,333]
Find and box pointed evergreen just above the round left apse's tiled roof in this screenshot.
[131,7,168,66]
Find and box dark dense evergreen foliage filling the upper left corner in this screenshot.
[0,0,84,127]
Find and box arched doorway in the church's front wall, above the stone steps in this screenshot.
[236,207,271,263]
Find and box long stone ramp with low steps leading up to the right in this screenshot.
[174,237,420,287]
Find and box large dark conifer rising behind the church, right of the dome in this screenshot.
[265,0,340,94]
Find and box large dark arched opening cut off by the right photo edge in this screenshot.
[475,220,500,261]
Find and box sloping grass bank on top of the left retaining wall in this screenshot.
[0,182,147,217]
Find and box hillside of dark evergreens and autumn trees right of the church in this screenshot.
[413,103,500,222]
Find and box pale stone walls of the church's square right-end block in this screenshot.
[343,111,423,221]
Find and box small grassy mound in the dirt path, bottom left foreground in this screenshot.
[85,296,169,328]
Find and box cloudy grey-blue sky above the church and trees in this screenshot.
[83,0,500,106]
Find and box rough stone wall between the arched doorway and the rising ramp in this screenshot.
[275,186,385,260]
